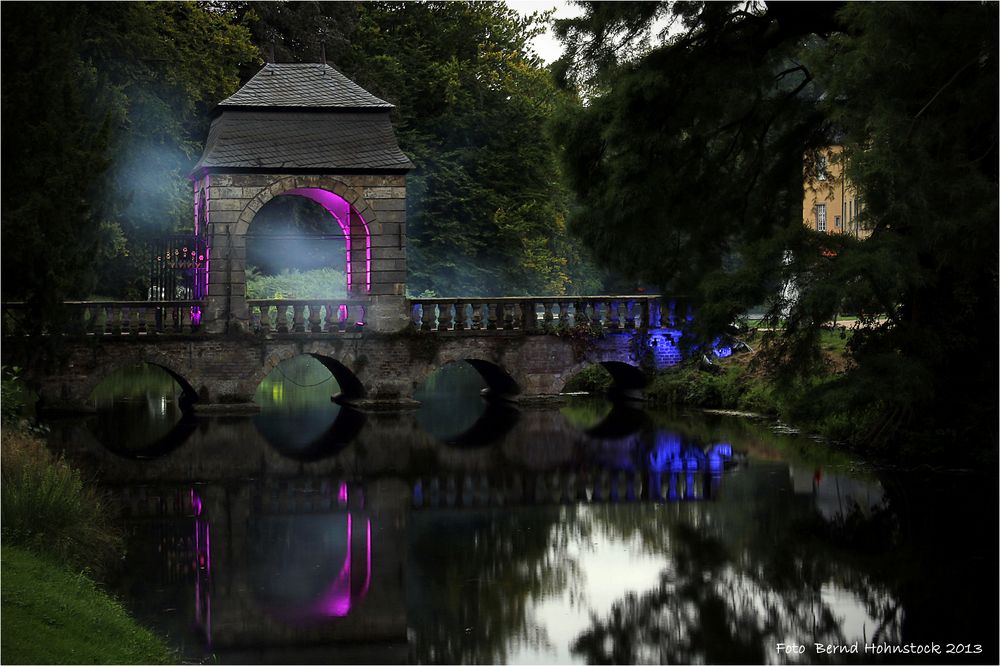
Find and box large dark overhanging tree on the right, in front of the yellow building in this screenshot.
[558,3,997,456]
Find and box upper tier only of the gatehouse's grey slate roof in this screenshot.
[219,63,393,109]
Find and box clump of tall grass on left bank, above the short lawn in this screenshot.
[0,431,122,574]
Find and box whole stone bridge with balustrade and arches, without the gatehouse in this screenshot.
[2,296,696,412]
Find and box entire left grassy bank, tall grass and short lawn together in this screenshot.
[0,428,173,664]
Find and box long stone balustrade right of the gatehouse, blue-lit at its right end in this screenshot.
[409,295,660,332]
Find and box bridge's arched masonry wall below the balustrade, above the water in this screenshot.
[3,331,660,409]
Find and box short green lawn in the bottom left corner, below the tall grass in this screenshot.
[0,546,175,664]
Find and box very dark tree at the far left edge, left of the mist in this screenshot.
[0,3,124,331]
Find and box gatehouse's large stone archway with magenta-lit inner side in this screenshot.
[233,175,382,295]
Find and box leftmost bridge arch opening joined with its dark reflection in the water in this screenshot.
[87,363,197,460]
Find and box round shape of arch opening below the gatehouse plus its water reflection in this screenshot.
[254,354,366,461]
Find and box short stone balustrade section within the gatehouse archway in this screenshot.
[247,299,368,334]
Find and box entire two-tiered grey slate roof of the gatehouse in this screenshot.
[194,63,413,172]
